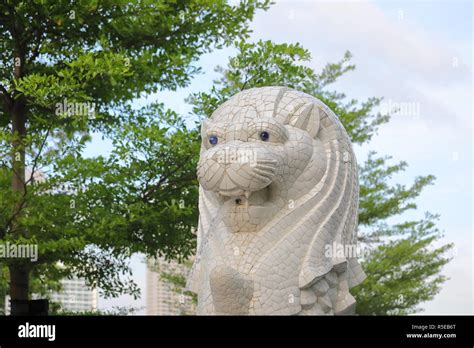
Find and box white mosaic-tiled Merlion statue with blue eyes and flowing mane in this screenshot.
[188,87,365,315]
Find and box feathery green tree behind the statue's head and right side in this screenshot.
[189,41,452,315]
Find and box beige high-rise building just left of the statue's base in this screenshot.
[146,258,195,315]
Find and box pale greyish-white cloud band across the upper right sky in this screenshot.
[254,1,470,82]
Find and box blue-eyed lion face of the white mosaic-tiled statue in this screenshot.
[198,108,324,232]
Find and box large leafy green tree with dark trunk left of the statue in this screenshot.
[0,0,268,314]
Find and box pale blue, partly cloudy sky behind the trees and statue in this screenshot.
[93,0,474,314]
